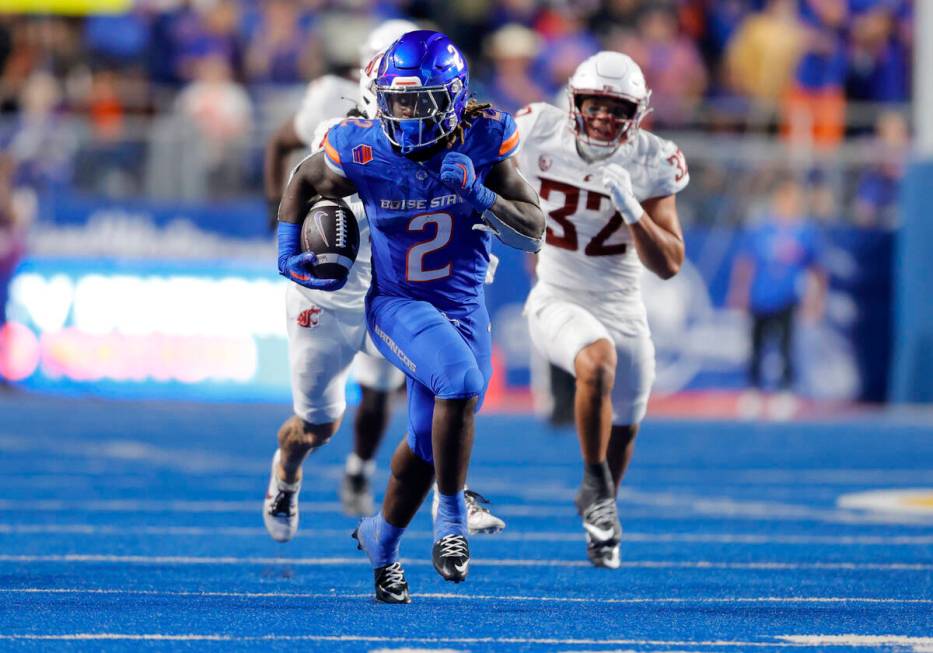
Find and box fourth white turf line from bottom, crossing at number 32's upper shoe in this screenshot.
[0,523,933,546]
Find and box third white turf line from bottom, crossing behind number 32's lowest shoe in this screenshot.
[0,553,933,571]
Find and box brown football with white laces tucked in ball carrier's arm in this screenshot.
[301,199,360,279]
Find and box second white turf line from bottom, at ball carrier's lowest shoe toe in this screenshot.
[0,587,933,605]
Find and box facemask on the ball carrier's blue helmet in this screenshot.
[376,77,466,154]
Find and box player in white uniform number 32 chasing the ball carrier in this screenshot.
[515,52,689,568]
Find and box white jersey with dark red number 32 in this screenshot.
[515,103,690,304]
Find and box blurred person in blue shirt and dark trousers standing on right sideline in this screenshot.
[729,176,826,390]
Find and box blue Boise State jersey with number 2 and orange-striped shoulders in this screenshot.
[324,109,518,308]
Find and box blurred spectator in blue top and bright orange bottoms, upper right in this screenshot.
[784,0,849,146]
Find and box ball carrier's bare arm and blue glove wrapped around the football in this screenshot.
[278,151,356,291]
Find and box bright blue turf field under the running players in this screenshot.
[0,395,933,651]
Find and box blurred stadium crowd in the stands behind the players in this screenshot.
[0,0,912,224]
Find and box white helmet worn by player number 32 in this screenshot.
[567,51,651,160]
